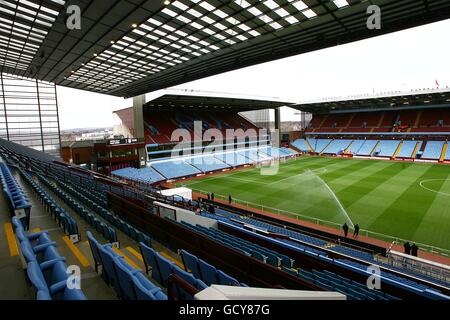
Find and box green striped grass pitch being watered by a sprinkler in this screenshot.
[178,157,450,249]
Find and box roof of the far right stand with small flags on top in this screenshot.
[290,88,450,113]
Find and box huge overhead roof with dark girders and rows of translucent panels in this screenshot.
[0,0,450,97]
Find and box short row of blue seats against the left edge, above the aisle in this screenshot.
[0,159,31,230]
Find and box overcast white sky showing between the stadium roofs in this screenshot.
[58,19,450,129]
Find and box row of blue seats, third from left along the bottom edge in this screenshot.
[139,243,208,300]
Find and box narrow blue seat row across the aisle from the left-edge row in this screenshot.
[19,168,80,242]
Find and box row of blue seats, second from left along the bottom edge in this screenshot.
[87,232,167,300]
